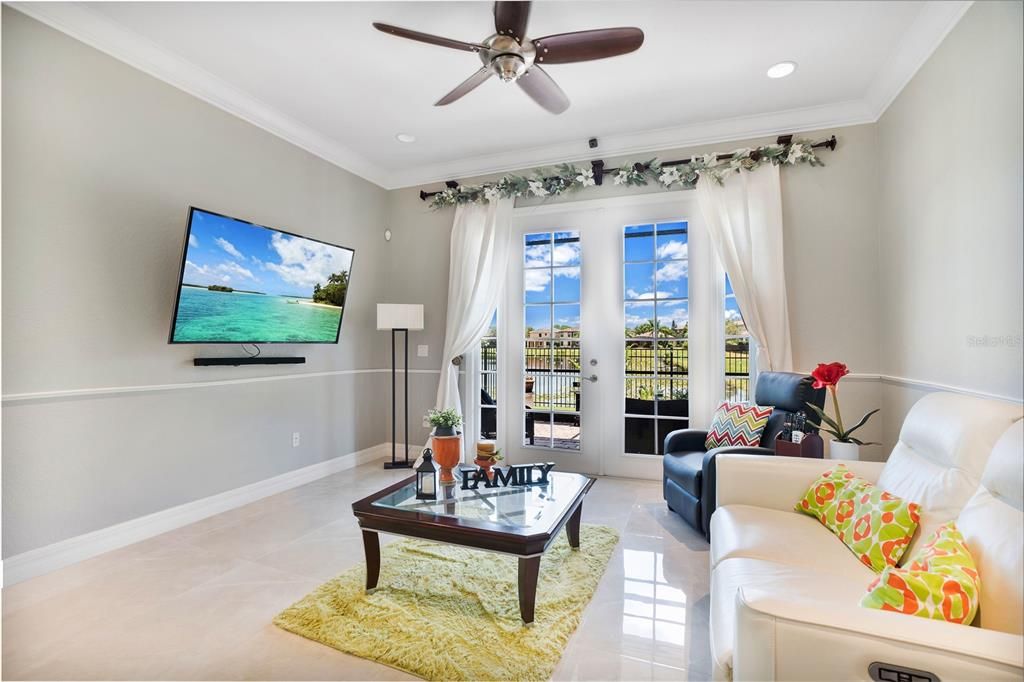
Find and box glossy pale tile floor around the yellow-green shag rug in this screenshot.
[2,464,711,680]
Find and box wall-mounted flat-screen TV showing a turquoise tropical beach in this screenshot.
[170,208,354,343]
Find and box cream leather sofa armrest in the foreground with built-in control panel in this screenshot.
[732,588,1024,681]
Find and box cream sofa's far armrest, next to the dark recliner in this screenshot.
[715,454,885,511]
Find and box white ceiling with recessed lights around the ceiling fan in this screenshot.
[12,0,970,188]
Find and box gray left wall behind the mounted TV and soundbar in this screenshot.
[2,7,390,557]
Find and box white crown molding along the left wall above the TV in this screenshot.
[5,2,386,186]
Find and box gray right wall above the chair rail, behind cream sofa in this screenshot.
[878,2,1024,409]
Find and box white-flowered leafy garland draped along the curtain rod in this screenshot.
[430,140,824,209]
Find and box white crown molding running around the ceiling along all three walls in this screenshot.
[7,1,973,189]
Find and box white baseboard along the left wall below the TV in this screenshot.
[0,442,391,586]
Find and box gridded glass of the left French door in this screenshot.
[523,231,582,451]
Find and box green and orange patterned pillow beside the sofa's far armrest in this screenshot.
[796,464,921,573]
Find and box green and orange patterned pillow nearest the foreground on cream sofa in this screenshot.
[860,522,981,625]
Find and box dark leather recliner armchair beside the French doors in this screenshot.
[663,372,825,539]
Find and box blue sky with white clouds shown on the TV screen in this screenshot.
[183,210,352,298]
